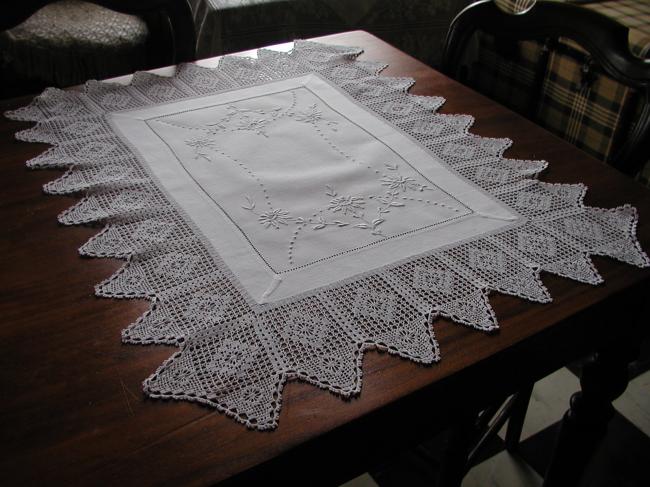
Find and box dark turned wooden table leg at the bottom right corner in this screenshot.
[544,341,639,487]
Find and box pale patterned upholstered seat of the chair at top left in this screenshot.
[0,0,149,86]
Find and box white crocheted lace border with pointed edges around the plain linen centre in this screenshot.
[7,41,650,429]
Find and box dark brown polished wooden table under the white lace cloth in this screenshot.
[0,31,650,486]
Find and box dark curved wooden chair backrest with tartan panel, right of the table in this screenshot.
[442,0,650,179]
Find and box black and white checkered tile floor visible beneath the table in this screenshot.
[341,341,650,487]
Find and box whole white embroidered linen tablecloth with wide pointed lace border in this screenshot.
[7,41,650,429]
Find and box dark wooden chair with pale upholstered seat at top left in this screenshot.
[0,0,196,95]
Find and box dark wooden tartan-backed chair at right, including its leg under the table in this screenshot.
[441,0,650,485]
